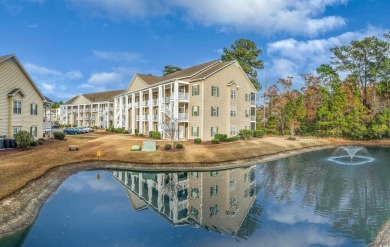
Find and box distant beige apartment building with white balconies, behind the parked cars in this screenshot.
[60,90,123,128]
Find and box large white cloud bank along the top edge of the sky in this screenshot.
[68,0,348,36]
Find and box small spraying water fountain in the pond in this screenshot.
[328,146,375,165]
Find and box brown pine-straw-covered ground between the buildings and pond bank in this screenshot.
[0,134,331,199]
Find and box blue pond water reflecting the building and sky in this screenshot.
[0,148,390,247]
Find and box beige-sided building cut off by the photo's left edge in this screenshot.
[0,55,47,139]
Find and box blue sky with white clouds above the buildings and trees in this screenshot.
[0,0,390,101]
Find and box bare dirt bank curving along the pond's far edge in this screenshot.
[0,145,334,238]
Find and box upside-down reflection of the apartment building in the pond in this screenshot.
[113,166,262,237]
